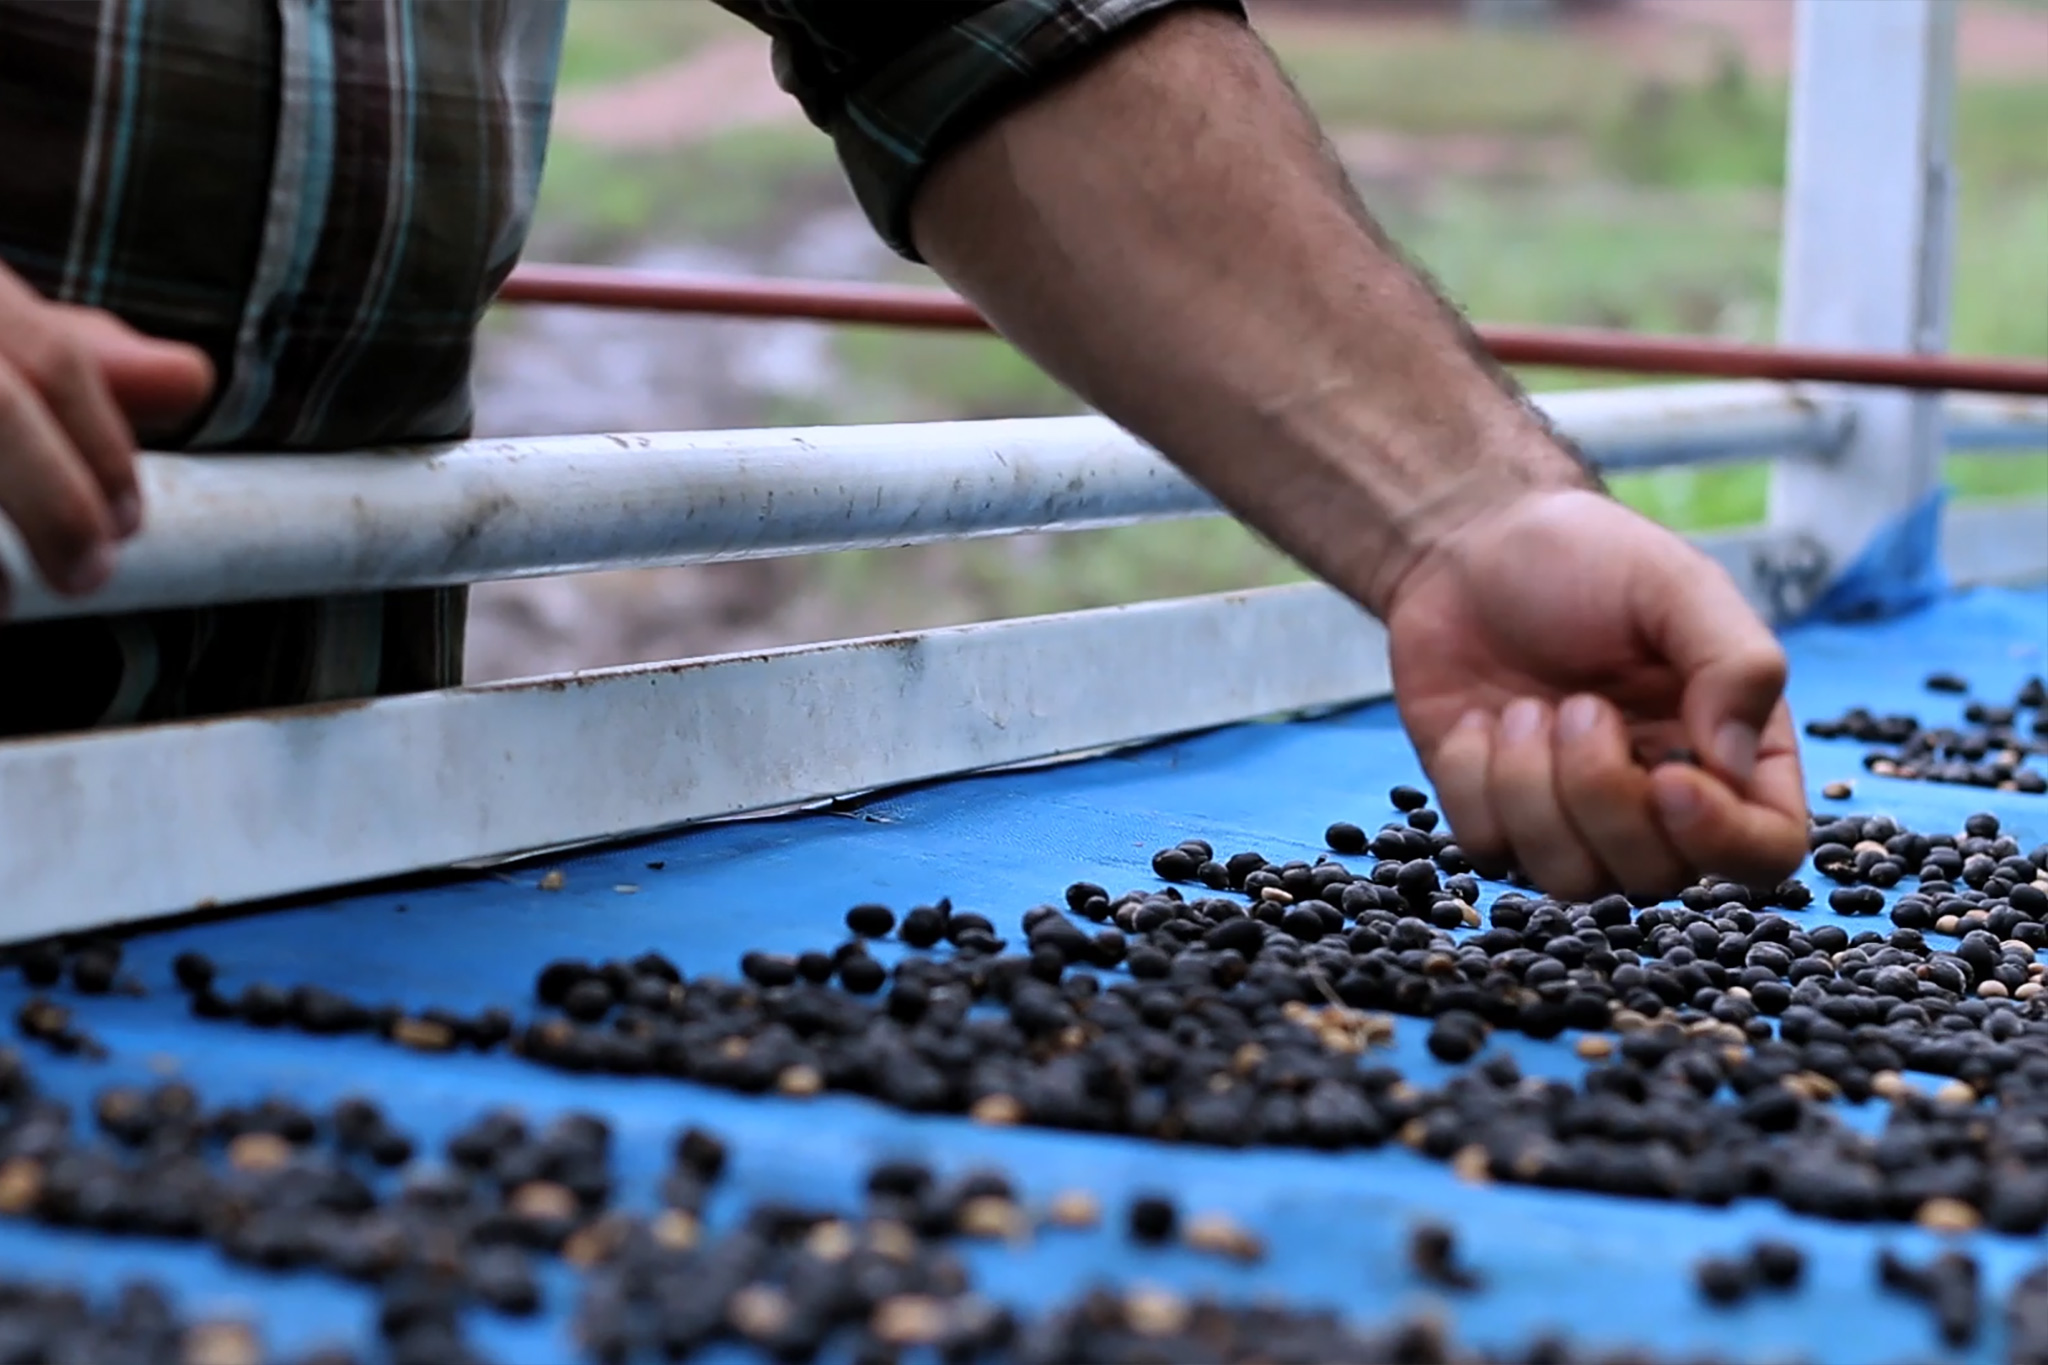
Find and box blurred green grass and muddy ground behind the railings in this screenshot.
[469,0,2048,681]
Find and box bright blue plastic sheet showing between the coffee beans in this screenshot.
[0,591,2048,1365]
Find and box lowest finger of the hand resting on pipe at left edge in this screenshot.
[0,362,113,593]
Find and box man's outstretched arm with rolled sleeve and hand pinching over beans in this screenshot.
[727,0,1804,896]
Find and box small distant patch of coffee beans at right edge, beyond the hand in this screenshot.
[1806,673,2048,794]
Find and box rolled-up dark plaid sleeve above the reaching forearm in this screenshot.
[719,0,1243,260]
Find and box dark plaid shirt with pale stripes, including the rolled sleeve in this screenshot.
[0,0,1239,735]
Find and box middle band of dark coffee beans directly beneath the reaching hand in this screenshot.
[119,788,2048,1234]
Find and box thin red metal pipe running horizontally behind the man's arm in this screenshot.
[498,264,2048,395]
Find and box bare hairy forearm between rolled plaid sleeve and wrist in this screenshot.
[911,10,1591,612]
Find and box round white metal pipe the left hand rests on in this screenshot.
[0,385,1843,620]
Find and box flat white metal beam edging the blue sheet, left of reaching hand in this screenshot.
[0,585,1389,939]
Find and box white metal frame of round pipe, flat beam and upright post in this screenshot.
[0,0,2048,939]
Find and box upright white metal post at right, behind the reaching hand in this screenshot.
[1769,0,1956,612]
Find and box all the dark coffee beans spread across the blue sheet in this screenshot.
[0,769,2048,1361]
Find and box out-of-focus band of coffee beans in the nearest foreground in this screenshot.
[0,1052,1802,1365]
